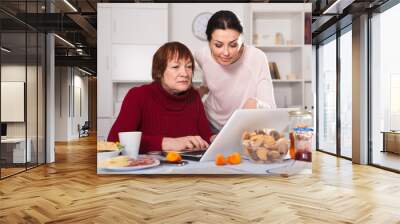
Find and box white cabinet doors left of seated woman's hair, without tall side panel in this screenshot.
[108,4,168,82]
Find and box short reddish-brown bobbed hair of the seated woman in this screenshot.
[151,42,194,82]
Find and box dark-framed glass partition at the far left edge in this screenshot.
[0,1,46,179]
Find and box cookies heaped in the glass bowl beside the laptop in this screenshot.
[242,129,289,163]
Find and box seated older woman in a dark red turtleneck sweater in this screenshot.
[108,42,211,153]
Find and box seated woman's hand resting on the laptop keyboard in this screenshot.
[161,136,208,151]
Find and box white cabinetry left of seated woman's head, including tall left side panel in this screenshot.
[97,3,168,122]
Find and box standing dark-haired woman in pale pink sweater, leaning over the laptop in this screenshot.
[196,11,276,133]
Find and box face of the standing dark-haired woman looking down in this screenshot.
[209,29,243,65]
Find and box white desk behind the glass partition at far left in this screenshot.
[1,138,32,163]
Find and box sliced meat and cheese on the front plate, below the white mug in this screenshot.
[99,156,156,167]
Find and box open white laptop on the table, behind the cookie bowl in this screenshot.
[181,109,289,162]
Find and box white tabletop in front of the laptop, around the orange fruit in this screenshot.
[97,156,311,175]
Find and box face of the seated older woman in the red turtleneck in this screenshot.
[161,57,193,94]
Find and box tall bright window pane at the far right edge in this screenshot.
[370,1,400,170]
